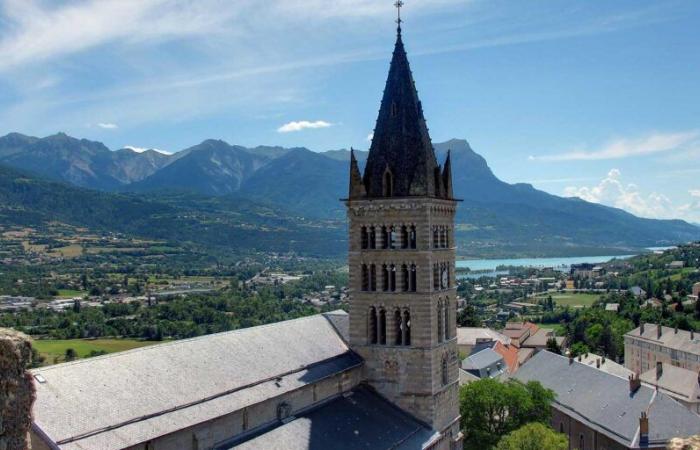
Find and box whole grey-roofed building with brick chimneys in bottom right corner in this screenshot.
[514,351,700,450]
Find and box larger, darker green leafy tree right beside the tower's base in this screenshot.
[460,378,554,449]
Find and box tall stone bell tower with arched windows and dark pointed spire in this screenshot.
[346,23,461,448]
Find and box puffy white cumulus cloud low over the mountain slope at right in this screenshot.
[564,169,679,218]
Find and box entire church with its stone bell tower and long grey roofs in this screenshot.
[31,10,462,450]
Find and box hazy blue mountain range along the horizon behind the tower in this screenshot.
[0,133,700,256]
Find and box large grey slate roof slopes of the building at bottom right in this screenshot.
[513,351,700,448]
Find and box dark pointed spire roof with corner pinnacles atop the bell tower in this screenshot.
[350,29,451,198]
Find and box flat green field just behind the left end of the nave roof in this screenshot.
[33,339,158,365]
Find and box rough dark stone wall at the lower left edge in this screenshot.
[0,328,35,450]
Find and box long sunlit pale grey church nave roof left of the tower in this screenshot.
[32,315,361,450]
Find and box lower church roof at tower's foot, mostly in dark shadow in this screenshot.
[229,386,434,450]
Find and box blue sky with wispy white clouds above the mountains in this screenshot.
[0,0,700,223]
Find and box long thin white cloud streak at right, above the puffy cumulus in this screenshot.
[529,130,700,161]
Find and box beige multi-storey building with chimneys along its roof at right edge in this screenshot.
[625,323,700,373]
